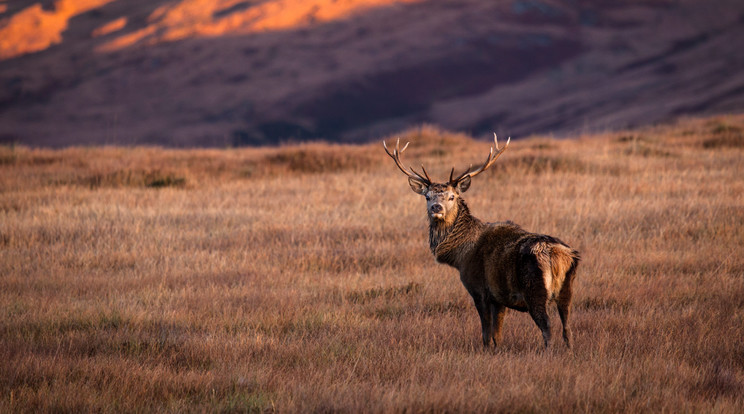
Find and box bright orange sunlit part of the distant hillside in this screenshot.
[0,0,420,59]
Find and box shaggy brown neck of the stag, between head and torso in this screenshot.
[429,199,483,269]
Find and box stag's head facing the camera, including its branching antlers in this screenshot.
[382,134,511,222]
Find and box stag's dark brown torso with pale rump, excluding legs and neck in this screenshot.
[468,222,579,312]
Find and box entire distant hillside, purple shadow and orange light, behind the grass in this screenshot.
[0,0,744,146]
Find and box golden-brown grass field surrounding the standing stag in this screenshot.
[0,116,744,413]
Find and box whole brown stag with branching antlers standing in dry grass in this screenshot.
[382,134,580,349]
